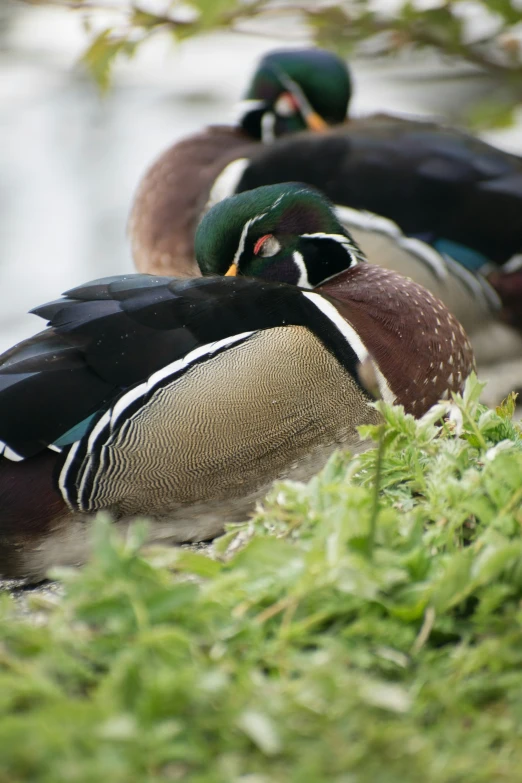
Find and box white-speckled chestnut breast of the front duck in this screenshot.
[316,264,475,416]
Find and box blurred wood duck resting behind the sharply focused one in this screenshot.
[129,49,522,331]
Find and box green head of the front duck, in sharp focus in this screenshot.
[195,182,364,288]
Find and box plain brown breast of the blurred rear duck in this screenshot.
[128,126,257,277]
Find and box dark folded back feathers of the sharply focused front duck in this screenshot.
[0,275,357,457]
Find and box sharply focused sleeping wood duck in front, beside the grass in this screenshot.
[0,184,473,581]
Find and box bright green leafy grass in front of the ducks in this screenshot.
[0,380,522,783]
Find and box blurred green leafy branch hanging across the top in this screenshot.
[26,0,522,127]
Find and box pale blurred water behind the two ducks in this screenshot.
[0,0,522,351]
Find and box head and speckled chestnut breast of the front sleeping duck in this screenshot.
[196,183,474,416]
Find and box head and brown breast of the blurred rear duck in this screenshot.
[129,49,351,276]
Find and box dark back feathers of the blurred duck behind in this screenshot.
[237,116,522,264]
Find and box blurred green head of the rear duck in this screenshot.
[241,49,351,141]
